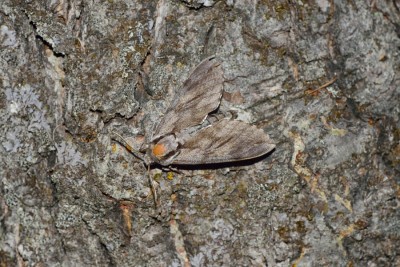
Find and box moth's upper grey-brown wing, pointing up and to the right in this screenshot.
[152,58,224,140]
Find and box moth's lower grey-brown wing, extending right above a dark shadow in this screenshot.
[173,119,275,165]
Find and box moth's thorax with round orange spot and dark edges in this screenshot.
[148,134,179,165]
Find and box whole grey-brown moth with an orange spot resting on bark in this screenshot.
[114,57,275,169]
